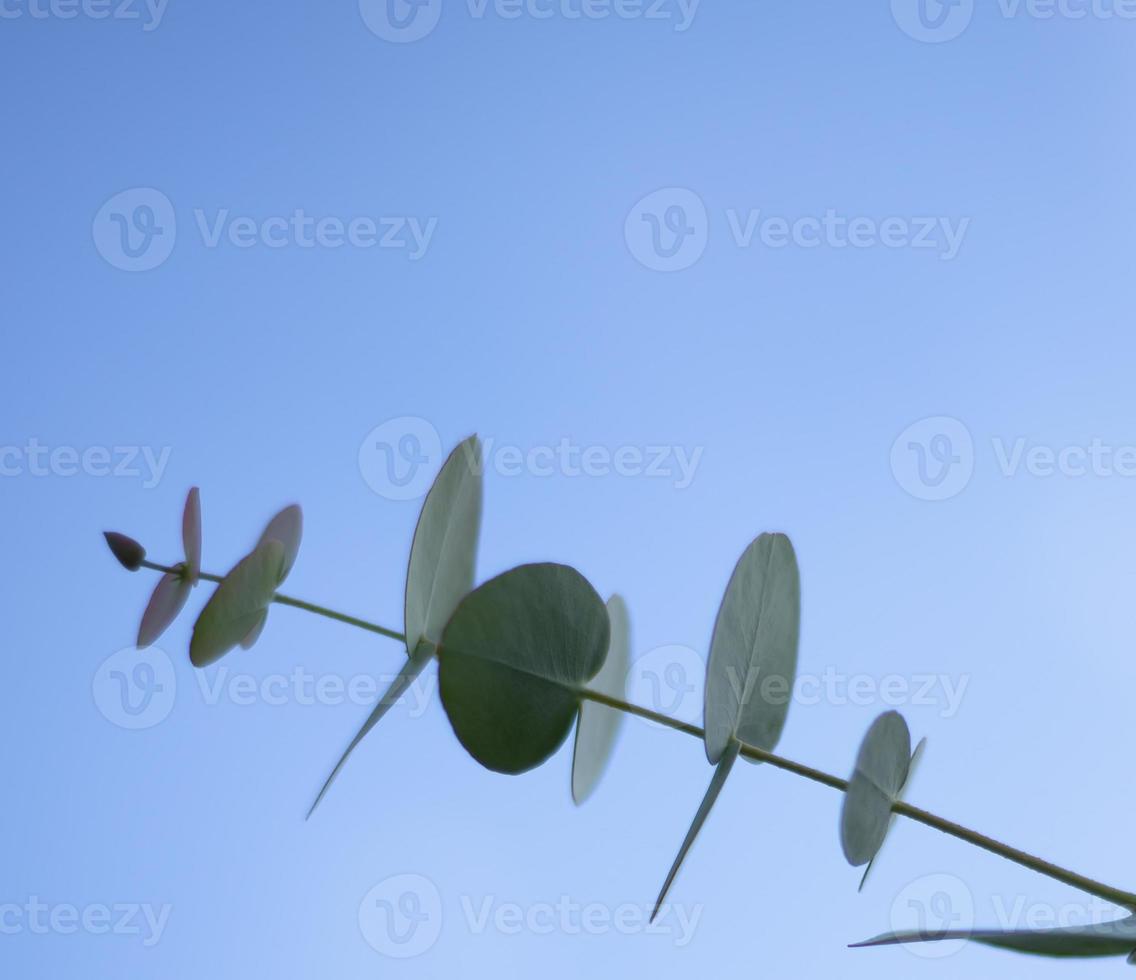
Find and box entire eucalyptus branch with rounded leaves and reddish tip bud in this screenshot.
[105,447,1136,962]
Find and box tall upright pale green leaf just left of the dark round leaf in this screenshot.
[406,436,482,654]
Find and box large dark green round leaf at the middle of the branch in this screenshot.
[438,564,610,773]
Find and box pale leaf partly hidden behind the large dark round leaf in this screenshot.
[571,595,630,805]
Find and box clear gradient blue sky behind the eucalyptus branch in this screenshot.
[0,0,1136,980]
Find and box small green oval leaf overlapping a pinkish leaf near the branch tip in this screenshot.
[190,538,284,667]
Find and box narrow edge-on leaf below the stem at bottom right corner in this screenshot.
[852,915,1136,956]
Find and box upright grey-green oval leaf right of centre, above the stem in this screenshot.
[705,534,801,764]
